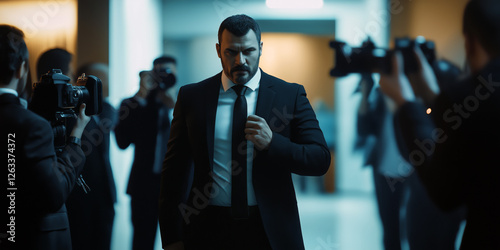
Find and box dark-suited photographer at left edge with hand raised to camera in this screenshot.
[0,25,90,250]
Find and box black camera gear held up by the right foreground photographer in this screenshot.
[330,37,436,77]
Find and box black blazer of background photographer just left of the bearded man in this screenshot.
[115,94,170,196]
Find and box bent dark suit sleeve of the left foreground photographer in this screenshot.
[24,117,85,213]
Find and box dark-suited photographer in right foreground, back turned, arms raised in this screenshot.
[380,0,500,249]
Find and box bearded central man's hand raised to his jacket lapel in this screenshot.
[245,115,273,150]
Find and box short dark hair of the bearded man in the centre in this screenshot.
[218,14,260,44]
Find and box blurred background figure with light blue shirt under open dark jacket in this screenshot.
[356,74,412,250]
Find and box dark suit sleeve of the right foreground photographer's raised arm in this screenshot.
[394,97,466,211]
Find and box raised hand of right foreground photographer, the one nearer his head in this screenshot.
[408,47,439,105]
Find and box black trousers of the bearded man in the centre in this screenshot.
[184,206,272,250]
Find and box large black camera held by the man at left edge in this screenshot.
[29,69,102,148]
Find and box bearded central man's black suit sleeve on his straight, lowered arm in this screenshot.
[159,88,191,247]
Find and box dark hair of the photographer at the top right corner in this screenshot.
[463,0,500,57]
